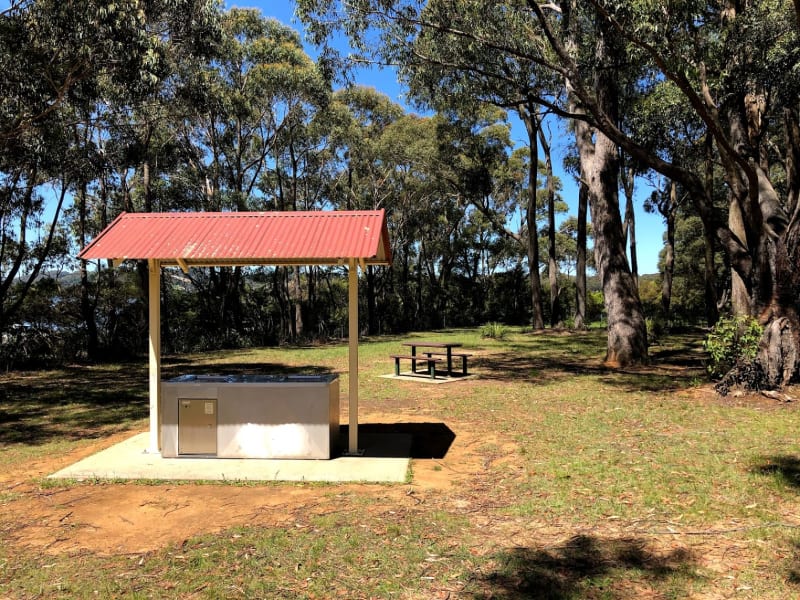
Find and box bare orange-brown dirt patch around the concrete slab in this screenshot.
[0,414,494,555]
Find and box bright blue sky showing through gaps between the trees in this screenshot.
[234,0,665,274]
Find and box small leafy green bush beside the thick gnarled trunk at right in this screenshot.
[703,316,764,378]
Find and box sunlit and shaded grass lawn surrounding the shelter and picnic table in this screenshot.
[0,329,800,600]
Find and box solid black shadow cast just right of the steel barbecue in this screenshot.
[339,423,456,459]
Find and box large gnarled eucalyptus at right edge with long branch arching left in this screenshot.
[529,0,800,385]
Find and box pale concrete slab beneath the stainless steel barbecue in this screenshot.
[49,433,412,483]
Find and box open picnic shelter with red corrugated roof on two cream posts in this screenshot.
[78,210,391,454]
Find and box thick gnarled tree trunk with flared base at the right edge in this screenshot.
[720,3,800,387]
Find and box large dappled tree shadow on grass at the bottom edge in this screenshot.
[473,535,697,600]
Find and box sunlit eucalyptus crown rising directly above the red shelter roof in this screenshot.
[176,9,328,210]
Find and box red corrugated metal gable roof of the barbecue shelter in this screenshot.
[78,210,391,266]
